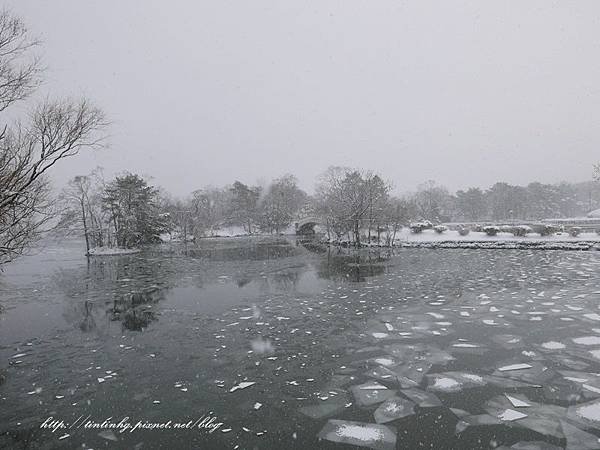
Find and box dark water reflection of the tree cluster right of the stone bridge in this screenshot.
[317,248,391,282]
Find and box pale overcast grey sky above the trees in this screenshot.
[5,0,600,195]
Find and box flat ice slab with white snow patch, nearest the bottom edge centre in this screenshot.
[318,419,396,450]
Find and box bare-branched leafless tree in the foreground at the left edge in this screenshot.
[0,11,106,264]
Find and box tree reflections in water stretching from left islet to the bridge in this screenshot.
[53,238,306,334]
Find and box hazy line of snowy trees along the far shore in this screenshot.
[60,167,600,250]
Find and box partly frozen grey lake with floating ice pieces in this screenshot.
[0,238,600,449]
